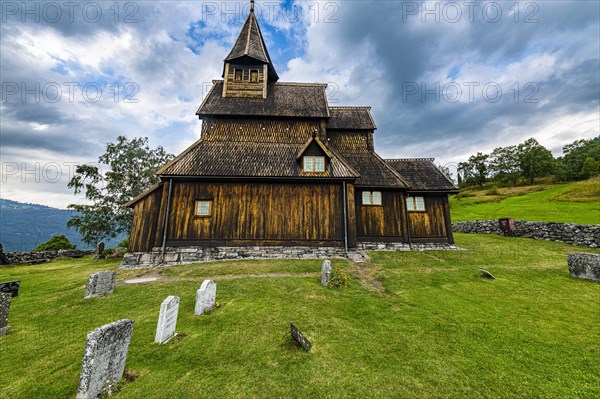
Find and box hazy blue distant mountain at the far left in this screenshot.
[0,198,126,252]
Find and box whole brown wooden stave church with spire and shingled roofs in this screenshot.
[127,2,457,260]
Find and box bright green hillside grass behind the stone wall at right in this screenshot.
[450,178,600,224]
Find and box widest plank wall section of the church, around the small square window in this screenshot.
[168,182,344,245]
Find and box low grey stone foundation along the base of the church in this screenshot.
[121,242,460,269]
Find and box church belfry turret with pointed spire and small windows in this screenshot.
[223,1,279,98]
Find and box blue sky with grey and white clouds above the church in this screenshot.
[0,0,600,208]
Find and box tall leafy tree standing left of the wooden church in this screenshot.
[67,136,173,244]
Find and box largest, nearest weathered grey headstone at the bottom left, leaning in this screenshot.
[76,320,133,399]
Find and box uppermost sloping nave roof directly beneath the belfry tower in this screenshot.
[196,80,329,118]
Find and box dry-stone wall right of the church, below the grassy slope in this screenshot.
[452,220,600,248]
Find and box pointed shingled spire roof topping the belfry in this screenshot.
[225,5,279,81]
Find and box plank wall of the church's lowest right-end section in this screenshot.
[408,195,448,241]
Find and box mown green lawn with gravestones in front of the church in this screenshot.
[0,234,600,399]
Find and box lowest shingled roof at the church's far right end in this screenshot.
[386,158,458,191]
